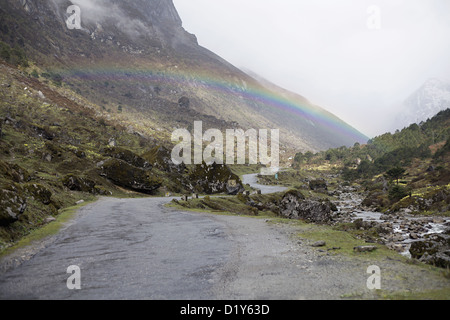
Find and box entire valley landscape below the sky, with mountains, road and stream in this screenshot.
[0,0,450,300]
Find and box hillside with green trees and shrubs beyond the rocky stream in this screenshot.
[294,109,450,213]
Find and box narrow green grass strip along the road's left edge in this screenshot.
[0,198,97,258]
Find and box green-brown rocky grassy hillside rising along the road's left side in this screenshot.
[0,59,246,250]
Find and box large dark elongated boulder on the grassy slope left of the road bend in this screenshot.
[101,159,161,194]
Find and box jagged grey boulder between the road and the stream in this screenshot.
[279,190,337,224]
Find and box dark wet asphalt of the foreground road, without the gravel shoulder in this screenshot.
[0,198,230,300]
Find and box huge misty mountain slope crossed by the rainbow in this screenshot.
[0,0,367,151]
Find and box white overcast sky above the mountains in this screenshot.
[174,0,450,137]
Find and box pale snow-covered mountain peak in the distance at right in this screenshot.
[395,79,450,129]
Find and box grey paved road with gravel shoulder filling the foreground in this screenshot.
[0,174,448,300]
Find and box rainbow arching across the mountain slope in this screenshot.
[46,64,369,143]
